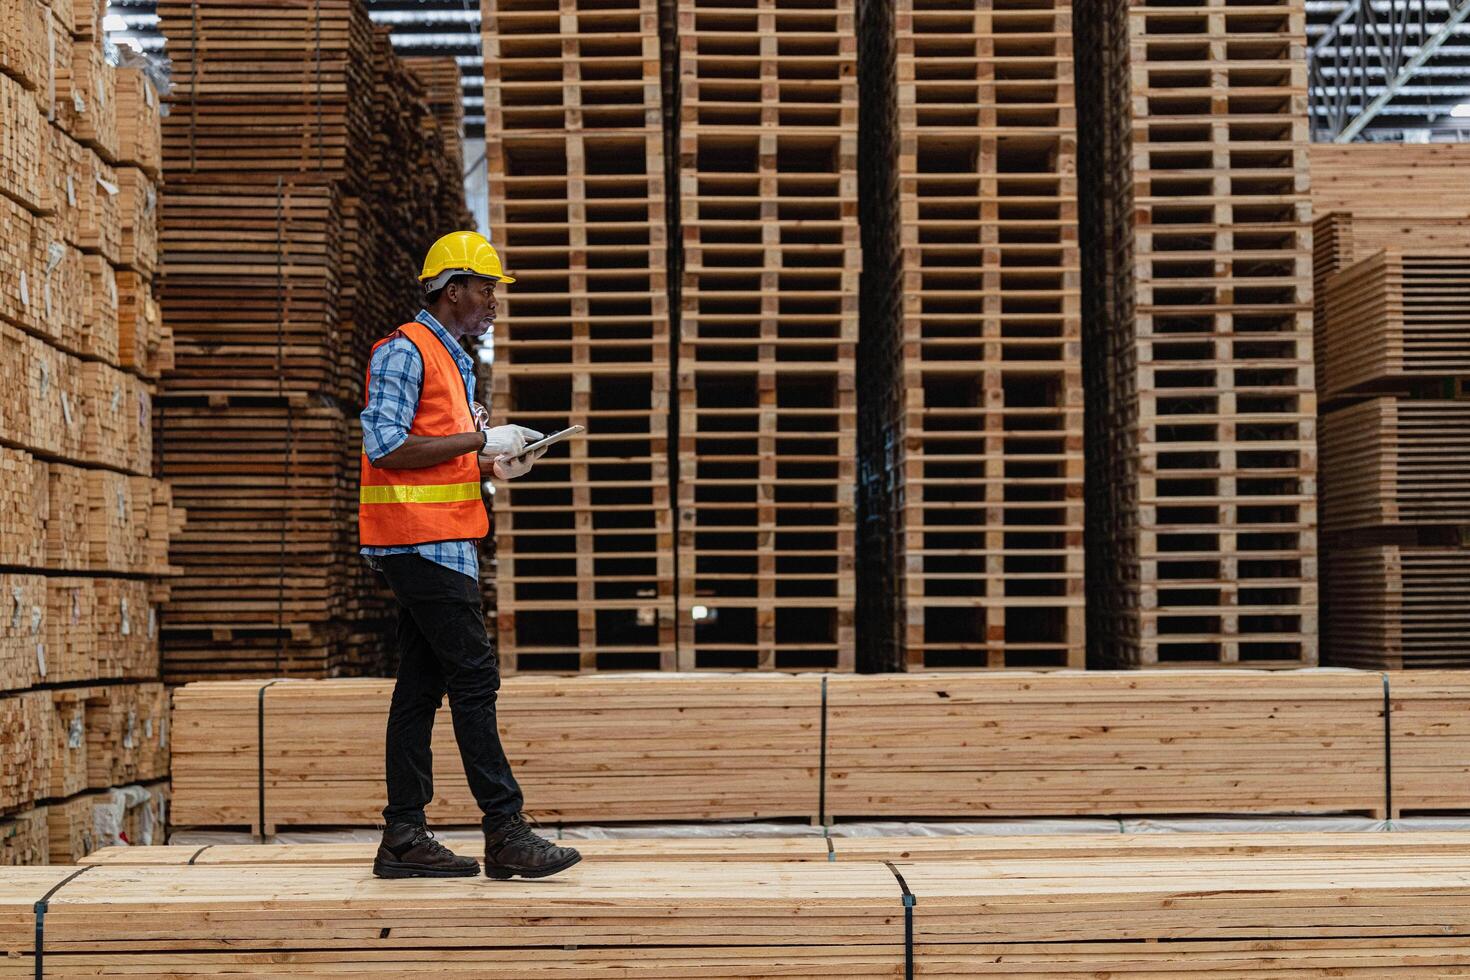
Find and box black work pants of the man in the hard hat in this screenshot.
[378,554,522,830]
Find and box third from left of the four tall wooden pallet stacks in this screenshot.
[858,0,1086,670]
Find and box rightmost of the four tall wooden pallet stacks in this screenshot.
[1076,0,1317,667]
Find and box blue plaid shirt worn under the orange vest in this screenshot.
[360,310,479,582]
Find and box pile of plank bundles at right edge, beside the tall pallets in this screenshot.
[1311,145,1470,667]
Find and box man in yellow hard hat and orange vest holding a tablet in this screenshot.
[357,231,582,879]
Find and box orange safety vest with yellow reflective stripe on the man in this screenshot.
[357,320,490,547]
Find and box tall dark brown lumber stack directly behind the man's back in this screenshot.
[155,0,466,682]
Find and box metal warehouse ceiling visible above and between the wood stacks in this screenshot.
[109,0,1470,151]
